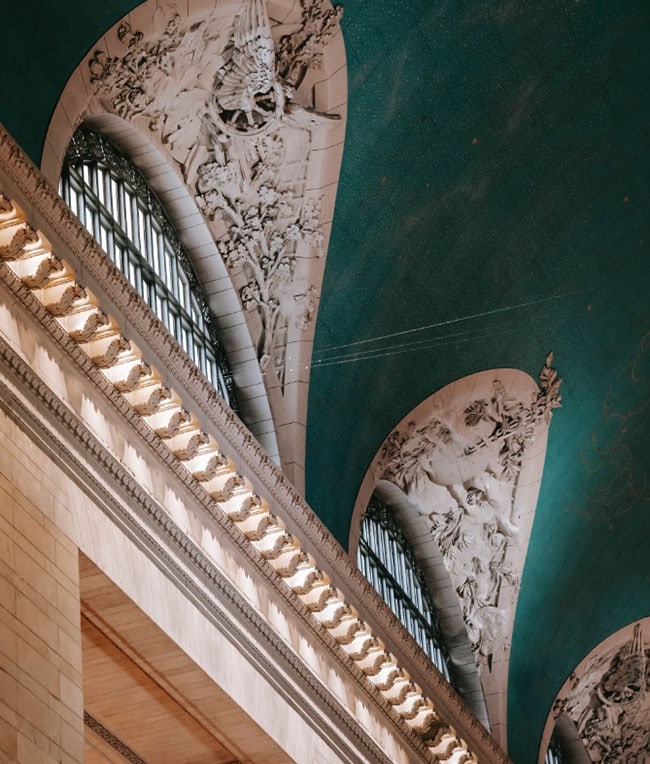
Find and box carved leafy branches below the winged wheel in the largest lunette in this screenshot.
[197,134,323,379]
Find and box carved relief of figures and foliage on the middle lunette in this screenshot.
[379,354,561,667]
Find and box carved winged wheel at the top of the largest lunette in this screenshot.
[211,0,339,135]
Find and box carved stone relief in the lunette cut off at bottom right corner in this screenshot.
[553,620,650,764]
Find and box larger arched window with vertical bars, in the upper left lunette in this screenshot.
[61,127,238,411]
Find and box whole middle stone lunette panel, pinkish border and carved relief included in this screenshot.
[349,362,560,745]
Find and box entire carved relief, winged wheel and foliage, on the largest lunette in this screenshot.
[89,0,341,385]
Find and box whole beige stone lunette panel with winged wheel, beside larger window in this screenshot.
[42,0,347,491]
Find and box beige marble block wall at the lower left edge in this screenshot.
[0,412,83,764]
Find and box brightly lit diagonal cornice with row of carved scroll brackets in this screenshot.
[0,122,505,762]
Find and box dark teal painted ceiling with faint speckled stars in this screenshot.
[0,0,650,764]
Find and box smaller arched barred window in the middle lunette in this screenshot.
[357,497,451,682]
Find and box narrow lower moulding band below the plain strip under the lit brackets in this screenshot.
[0,324,394,764]
